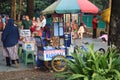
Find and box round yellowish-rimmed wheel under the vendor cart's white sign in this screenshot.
[51,55,67,72]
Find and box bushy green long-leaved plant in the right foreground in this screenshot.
[55,44,120,80]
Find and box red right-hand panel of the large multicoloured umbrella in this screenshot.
[77,0,99,13]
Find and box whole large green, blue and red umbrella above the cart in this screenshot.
[42,0,99,14]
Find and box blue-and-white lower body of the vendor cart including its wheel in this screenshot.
[35,36,66,72]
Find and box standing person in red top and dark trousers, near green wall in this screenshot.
[92,15,98,39]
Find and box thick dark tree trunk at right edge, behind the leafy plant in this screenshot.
[109,0,120,52]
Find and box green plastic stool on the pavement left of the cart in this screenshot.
[23,50,35,65]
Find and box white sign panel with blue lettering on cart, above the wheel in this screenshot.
[38,50,65,61]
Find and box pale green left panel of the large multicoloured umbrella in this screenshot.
[42,0,61,14]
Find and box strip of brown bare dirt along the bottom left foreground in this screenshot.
[0,69,55,80]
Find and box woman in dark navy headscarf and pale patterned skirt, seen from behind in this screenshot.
[1,18,19,67]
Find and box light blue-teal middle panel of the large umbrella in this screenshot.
[55,0,80,14]
